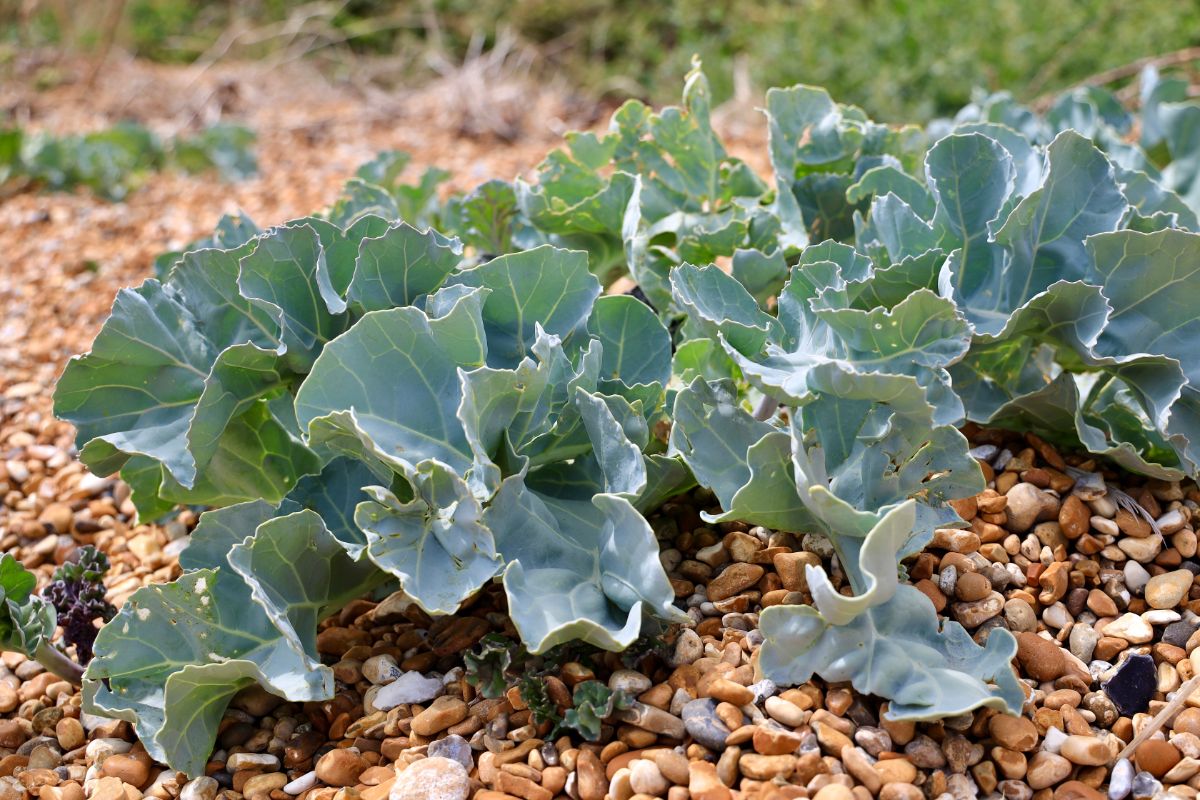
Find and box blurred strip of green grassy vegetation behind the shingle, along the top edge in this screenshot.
[7,0,1200,121]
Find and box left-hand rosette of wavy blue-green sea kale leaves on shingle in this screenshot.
[56,209,691,774]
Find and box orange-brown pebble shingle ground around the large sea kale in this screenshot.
[0,54,1200,800]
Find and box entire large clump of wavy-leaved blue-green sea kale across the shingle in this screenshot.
[56,62,1200,775]
